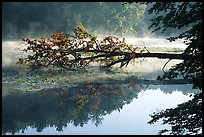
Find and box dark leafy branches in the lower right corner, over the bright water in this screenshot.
[148,92,202,135]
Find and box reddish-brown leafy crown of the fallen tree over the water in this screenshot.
[17,24,148,69]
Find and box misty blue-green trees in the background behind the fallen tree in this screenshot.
[2,2,145,40]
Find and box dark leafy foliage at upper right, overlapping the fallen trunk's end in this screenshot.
[148,2,202,88]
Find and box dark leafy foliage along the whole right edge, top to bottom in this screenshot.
[148,2,202,135]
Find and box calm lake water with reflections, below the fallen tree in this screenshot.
[2,40,199,135]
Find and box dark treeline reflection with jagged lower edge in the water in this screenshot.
[2,84,142,134]
